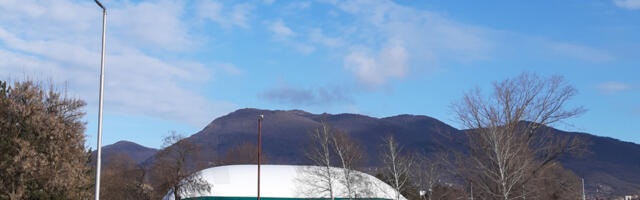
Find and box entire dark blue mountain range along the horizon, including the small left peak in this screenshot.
[96,108,640,194]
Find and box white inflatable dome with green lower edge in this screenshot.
[163,165,406,200]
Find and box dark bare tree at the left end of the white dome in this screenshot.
[152,132,211,200]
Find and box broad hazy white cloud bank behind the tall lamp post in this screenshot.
[0,27,234,126]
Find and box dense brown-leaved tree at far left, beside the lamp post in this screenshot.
[0,81,92,199]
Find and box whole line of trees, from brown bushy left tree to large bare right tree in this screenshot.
[0,73,585,200]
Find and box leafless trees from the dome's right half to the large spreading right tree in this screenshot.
[288,73,586,200]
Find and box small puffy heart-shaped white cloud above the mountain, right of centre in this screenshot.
[344,45,408,87]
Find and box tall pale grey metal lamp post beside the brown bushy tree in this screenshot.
[94,0,107,200]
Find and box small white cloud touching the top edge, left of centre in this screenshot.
[195,0,254,28]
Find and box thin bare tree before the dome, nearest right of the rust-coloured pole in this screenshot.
[299,122,338,200]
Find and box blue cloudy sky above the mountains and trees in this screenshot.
[0,0,640,148]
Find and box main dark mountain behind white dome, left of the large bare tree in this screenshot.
[189,109,460,164]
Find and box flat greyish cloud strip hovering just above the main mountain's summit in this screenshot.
[258,84,351,106]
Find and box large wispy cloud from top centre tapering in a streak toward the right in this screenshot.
[294,0,616,88]
